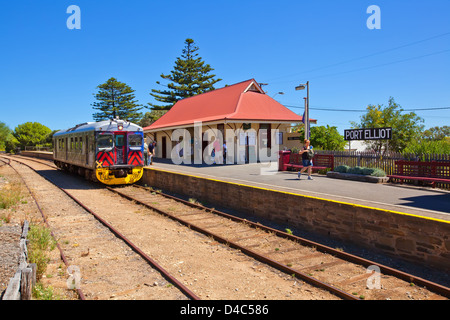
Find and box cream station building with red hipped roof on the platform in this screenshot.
[144,79,315,163]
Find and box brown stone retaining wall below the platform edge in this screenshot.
[143,169,450,272]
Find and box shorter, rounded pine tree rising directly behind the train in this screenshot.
[92,78,142,122]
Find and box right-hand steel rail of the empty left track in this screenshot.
[3,159,200,300]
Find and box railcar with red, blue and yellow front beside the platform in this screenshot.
[53,118,144,185]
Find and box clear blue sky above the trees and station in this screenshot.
[0,0,450,133]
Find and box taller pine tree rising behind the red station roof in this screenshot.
[149,39,222,110]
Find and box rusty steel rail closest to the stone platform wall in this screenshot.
[133,185,450,298]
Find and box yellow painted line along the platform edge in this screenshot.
[144,167,450,224]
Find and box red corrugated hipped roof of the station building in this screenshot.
[144,79,302,131]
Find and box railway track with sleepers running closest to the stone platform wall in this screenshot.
[3,155,450,300]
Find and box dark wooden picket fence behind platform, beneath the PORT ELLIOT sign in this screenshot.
[316,150,450,174]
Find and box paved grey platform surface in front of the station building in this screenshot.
[149,159,450,221]
